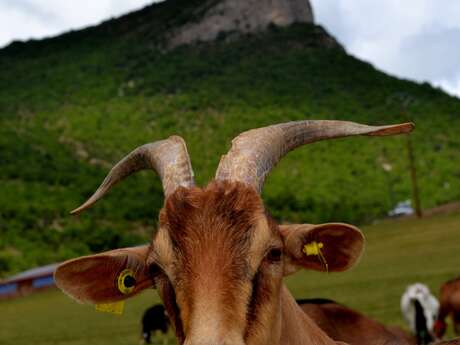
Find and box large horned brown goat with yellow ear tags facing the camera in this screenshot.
[55,121,413,345]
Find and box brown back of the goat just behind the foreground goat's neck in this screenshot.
[297,299,417,345]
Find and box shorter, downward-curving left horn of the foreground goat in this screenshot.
[70,136,195,214]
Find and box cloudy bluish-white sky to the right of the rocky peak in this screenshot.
[312,0,460,96]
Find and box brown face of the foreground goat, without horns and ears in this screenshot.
[154,182,283,344]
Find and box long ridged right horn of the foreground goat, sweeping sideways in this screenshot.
[216,120,414,193]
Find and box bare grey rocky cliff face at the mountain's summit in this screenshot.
[169,0,313,47]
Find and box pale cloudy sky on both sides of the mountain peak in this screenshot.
[0,0,460,97]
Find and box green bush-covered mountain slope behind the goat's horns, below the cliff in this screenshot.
[0,0,460,275]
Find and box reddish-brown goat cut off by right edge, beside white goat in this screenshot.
[434,277,460,338]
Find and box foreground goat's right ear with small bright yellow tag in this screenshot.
[280,223,364,275]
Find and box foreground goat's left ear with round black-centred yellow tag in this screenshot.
[54,245,153,304]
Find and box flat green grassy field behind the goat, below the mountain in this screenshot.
[0,213,460,345]
